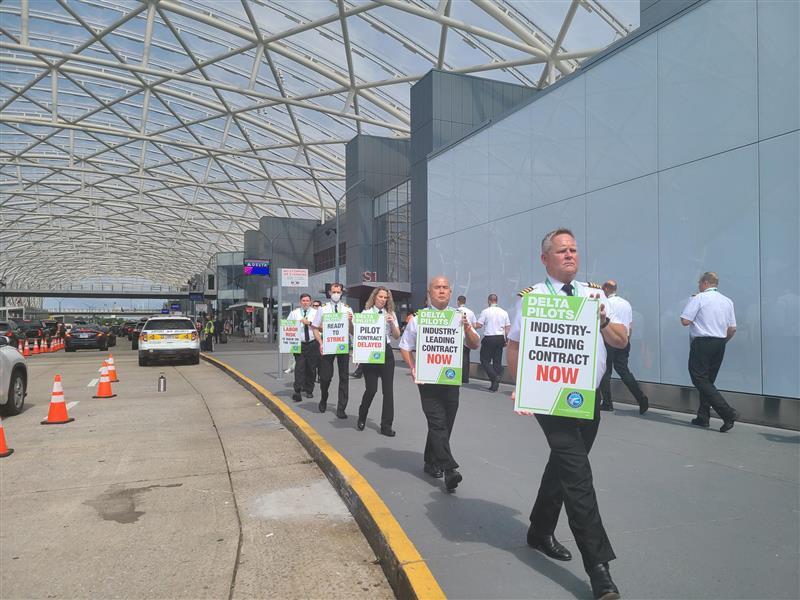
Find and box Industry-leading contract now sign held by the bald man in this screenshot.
[416,309,464,385]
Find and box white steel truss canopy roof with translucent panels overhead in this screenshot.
[0,0,638,285]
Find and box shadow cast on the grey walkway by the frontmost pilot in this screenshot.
[425,493,591,598]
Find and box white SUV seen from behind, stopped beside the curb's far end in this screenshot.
[139,315,200,367]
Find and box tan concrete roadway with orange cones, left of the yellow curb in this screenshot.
[0,342,393,600]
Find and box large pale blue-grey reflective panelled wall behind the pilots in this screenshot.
[428,0,800,398]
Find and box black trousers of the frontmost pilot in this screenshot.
[531,402,616,571]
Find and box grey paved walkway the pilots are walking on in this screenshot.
[213,341,800,598]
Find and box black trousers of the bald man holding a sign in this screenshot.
[417,383,459,469]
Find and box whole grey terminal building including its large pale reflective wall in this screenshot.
[230,0,800,425]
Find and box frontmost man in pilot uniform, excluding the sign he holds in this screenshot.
[506,229,628,600]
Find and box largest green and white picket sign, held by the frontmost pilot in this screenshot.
[514,294,603,419]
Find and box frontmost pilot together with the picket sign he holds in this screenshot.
[506,229,627,600]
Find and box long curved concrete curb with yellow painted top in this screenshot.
[200,353,445,600]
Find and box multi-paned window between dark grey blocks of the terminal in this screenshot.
[372,181,411,282]
